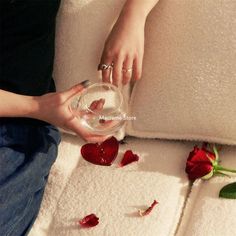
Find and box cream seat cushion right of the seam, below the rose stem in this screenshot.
[177,146,236,236]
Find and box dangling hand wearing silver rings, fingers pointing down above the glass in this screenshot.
[100,10,145,86]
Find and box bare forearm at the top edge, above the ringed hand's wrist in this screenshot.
[121,0,159,23]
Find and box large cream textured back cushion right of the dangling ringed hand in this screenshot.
[127,0,236,144]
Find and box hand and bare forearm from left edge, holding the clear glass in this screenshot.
[0,81,108,142]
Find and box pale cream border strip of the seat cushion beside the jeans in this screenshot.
[29,134,82,236]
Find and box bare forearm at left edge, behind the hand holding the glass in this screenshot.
[0,89,38,118]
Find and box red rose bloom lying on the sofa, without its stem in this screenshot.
[185,146,216,180]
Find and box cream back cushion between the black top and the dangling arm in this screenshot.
[54,0,129,139]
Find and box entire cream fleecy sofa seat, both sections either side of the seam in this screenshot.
[30,134,236,236]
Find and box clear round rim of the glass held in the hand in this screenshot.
[78,82,124,115]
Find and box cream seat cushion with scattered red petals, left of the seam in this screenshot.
[30,134,193,236]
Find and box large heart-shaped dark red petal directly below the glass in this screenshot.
[81,137,119,166]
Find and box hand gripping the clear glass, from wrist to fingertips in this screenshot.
[33,81,107,142]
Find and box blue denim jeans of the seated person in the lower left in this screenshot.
[0,119,60,236]
